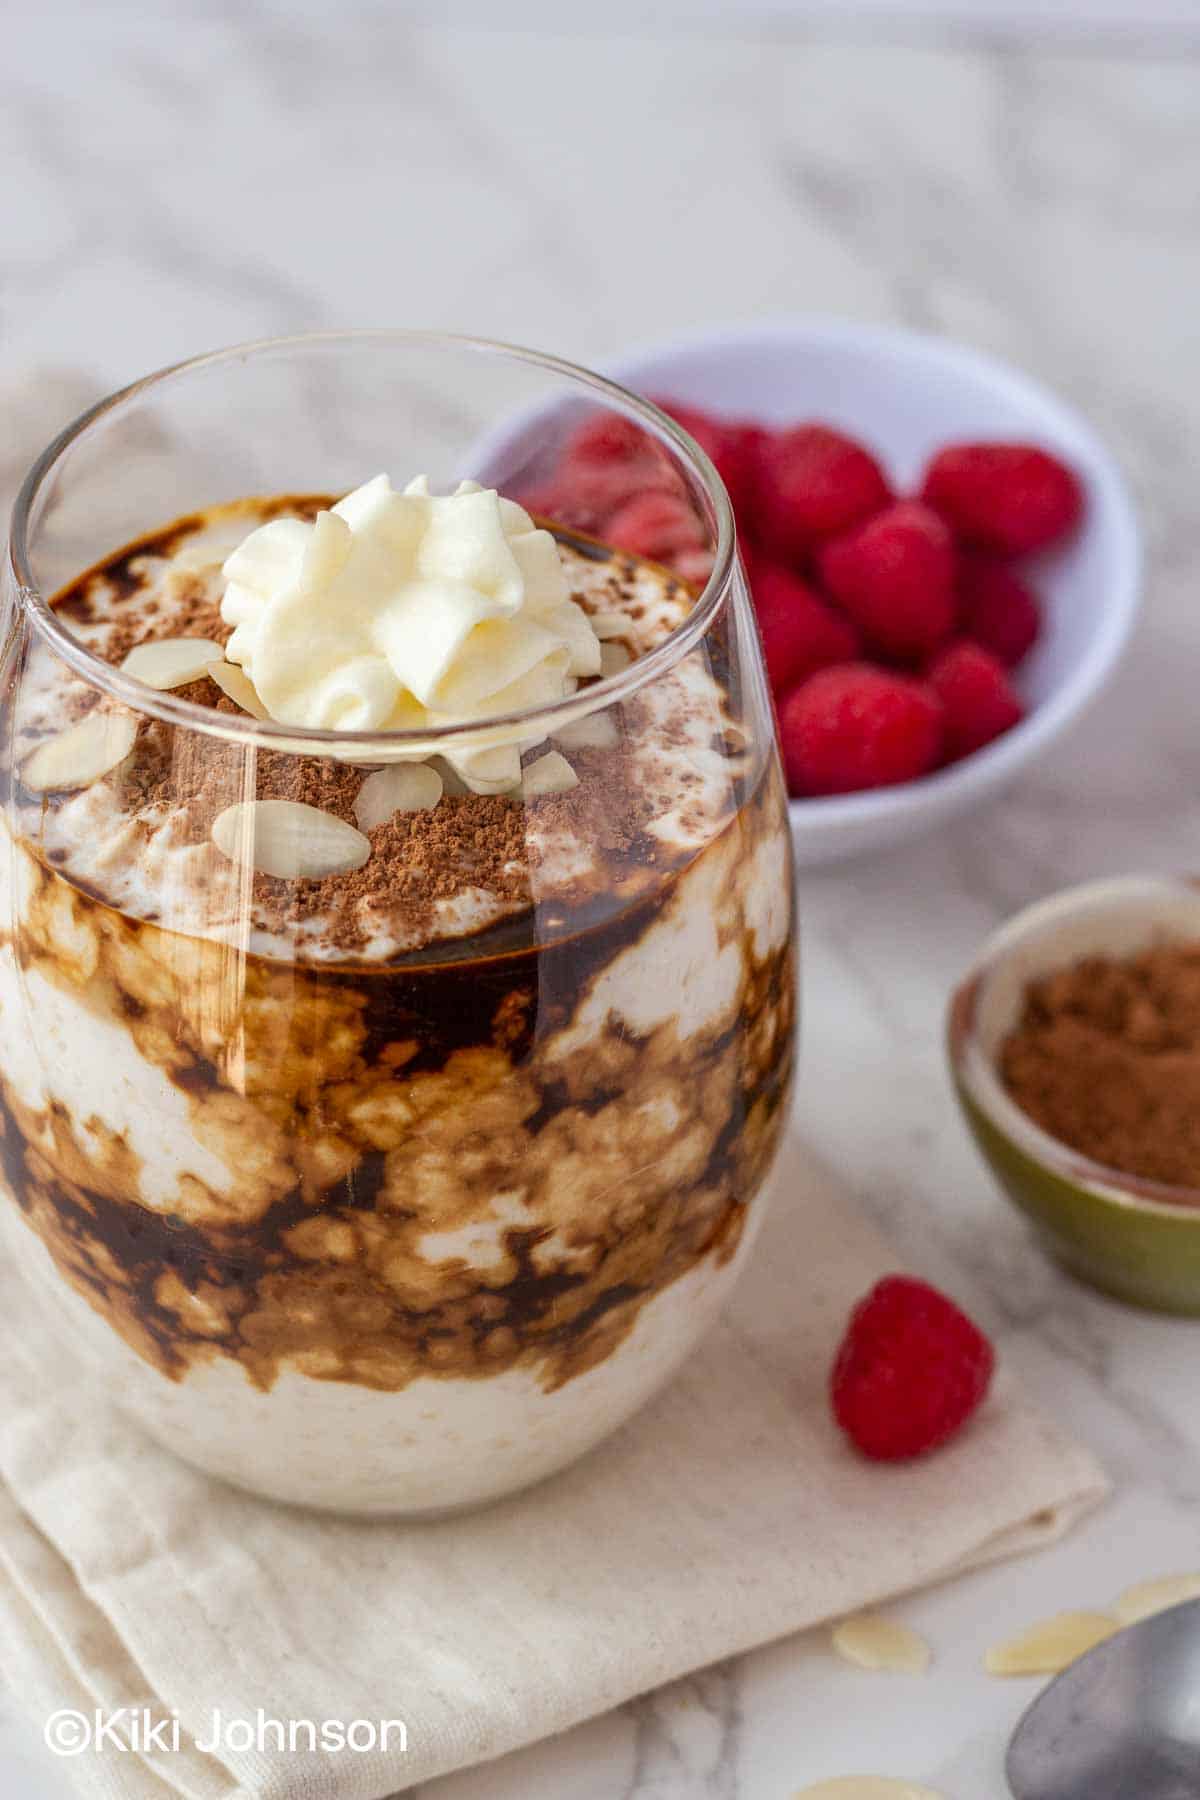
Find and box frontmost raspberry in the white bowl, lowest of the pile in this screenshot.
[779,662,941,794]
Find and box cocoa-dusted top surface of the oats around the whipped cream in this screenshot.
[14,499,763,963]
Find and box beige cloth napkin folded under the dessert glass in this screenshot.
[0,1139,1105,1800]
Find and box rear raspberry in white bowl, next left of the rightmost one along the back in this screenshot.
[754,425,891,562]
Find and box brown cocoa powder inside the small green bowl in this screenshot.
[999,943,1200,1190]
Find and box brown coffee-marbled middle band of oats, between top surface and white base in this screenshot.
[0,779,793,1391]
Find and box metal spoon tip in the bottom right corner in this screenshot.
[1006,1600,1200,1800]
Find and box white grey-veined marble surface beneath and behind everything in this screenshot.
[0,4,1200,1800]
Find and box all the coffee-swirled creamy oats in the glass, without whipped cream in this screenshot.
[0,508,793,1512]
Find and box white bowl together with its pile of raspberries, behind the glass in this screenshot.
[582,319,1141,864]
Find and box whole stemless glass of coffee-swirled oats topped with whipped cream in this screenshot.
[0,333,795,1516]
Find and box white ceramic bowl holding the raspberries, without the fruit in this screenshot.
[604,319,1141,864]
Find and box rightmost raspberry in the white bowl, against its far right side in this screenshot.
[921,445,1083,556]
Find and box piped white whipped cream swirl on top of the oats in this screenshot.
[221,475,601,794]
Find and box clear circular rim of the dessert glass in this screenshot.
[9,328,734,760]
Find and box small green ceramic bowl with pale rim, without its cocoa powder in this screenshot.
[948,877,1200,1316]
